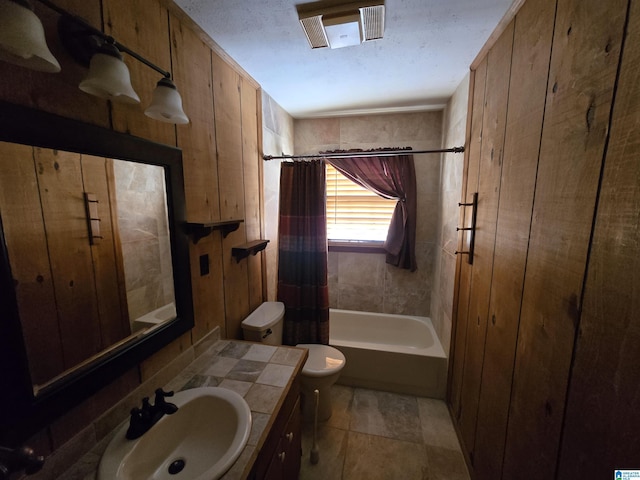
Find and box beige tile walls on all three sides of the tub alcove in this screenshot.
[262,88,469,353]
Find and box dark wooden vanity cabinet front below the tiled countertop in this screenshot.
[249,378,302,480]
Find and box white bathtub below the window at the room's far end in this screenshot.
[329,309,447,399]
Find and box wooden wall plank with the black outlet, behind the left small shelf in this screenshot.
[170,15,225,343]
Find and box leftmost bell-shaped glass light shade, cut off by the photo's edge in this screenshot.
[0,0,60,73]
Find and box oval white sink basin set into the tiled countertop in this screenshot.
[97,387,251,480]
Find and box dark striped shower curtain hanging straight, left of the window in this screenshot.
[277,160,329,345]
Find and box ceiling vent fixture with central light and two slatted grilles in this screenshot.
[298,0,384,48]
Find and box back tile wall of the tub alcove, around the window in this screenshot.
[294,112,442,316]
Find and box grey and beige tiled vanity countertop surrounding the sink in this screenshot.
[49,340,307,480]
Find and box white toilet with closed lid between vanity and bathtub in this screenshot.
[242,302,346,421]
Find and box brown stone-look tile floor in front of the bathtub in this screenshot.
[300,385,469,480]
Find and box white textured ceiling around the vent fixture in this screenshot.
[175,0,512,118]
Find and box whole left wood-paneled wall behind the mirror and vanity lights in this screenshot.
[0,0,263,460]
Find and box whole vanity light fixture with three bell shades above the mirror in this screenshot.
[0,0,189,124]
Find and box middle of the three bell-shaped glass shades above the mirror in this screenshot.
[78,44,140,104]
